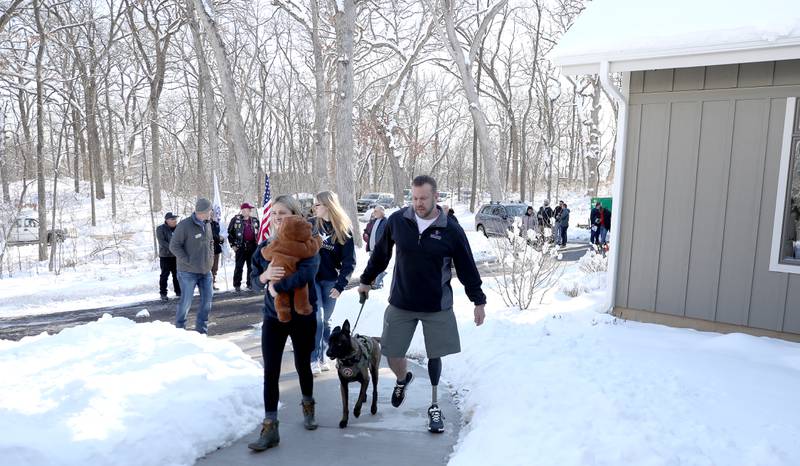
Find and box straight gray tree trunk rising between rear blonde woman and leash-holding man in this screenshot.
[334,0,361,247]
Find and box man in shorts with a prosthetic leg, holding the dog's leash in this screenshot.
[358,175,486,433]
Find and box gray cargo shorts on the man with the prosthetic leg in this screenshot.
[381,304,461,359]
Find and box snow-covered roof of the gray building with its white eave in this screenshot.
[550,0,800,74]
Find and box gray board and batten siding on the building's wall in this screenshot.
[615,60,800,333]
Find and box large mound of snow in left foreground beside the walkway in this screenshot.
[0,316,263,466]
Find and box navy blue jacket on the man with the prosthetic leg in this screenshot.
[361,207,486,312]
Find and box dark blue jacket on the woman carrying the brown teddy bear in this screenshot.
[250,240,319,319]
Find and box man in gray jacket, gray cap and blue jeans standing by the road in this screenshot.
[169,198,214,333]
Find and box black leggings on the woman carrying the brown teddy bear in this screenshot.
[261,311,317,413]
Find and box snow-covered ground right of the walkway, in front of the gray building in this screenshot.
[333,242,800,466]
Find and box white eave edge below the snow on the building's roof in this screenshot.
[553,39,800,76]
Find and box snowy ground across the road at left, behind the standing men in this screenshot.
[0,179,238,318]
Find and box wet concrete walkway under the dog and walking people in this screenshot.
[196,332,461,466]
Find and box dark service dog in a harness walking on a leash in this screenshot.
[325,320,381,429]
